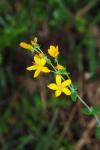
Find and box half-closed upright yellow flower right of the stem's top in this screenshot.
[48,45,59,58]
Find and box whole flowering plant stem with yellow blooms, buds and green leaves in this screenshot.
[20,38,100,138]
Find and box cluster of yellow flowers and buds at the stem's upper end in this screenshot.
[20,38,71,97]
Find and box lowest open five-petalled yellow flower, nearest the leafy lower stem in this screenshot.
[48,75,71,97]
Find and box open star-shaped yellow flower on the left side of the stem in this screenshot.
[26,54,50,78]
